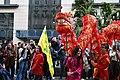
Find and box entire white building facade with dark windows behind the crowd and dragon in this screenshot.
[0,0,120,43]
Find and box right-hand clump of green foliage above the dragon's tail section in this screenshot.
[97,2,117,29]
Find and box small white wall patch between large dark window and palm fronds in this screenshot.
[61,0,74,12]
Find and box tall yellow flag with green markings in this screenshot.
[38,26,54,76]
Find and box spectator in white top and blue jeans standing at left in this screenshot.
[16,43,30,80]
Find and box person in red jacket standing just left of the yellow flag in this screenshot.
[32,46,44,80]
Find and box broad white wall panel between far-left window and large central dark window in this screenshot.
[10,0,29,30]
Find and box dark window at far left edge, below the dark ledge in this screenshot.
[0,13,14,39]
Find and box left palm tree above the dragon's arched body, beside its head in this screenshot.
[72,0,96,37]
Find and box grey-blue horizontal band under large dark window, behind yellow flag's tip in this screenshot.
[16,29,58,39]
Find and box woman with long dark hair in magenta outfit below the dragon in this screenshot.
[65,46,83,80]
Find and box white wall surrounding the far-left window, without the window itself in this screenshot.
[0,0,29,43]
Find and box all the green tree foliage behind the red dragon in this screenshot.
[72,0,120,37]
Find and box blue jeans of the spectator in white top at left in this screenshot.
[16,60,28,80]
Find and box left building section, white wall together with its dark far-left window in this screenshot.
[0,0,29,42]
